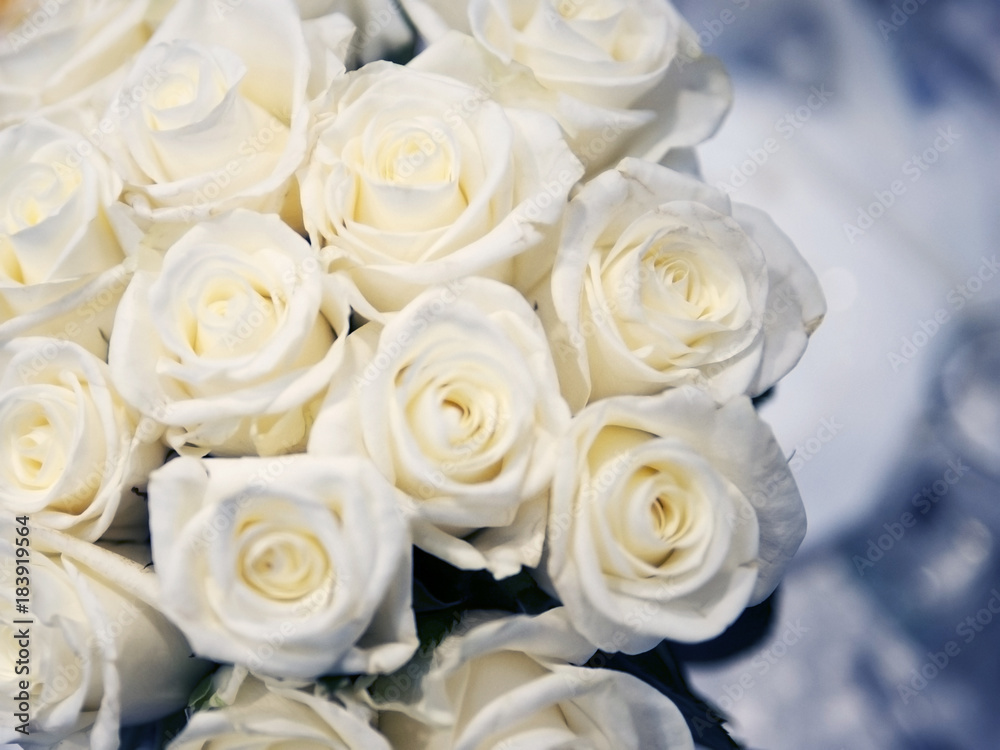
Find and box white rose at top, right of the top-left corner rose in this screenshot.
[101,0,318,224]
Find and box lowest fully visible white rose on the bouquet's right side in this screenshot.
[539,386,806,654]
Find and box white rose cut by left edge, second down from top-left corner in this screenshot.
[0,119,137,357]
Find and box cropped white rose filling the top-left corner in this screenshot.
[0,0,150,129]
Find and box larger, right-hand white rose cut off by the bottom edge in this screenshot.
[373,609,694,750]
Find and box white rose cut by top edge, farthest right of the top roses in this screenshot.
[394,0,732,174]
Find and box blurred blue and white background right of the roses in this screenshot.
[677,0,1000,750]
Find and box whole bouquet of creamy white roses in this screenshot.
[0,0,824,750]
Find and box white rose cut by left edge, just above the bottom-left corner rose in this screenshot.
[0,337,165,541]
